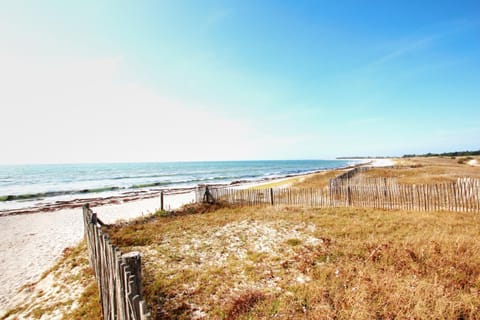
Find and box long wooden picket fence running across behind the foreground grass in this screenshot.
[197,178,480,212]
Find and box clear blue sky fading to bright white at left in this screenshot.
[0,0,480,163]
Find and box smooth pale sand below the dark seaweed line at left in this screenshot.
[0,192,195,315]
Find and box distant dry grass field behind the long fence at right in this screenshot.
[362,157,480,184]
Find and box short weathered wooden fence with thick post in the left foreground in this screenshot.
[83,204,150,320]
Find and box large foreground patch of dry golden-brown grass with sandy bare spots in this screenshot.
[109,206,480,319]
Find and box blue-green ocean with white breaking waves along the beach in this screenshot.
[0,160,355,211]
